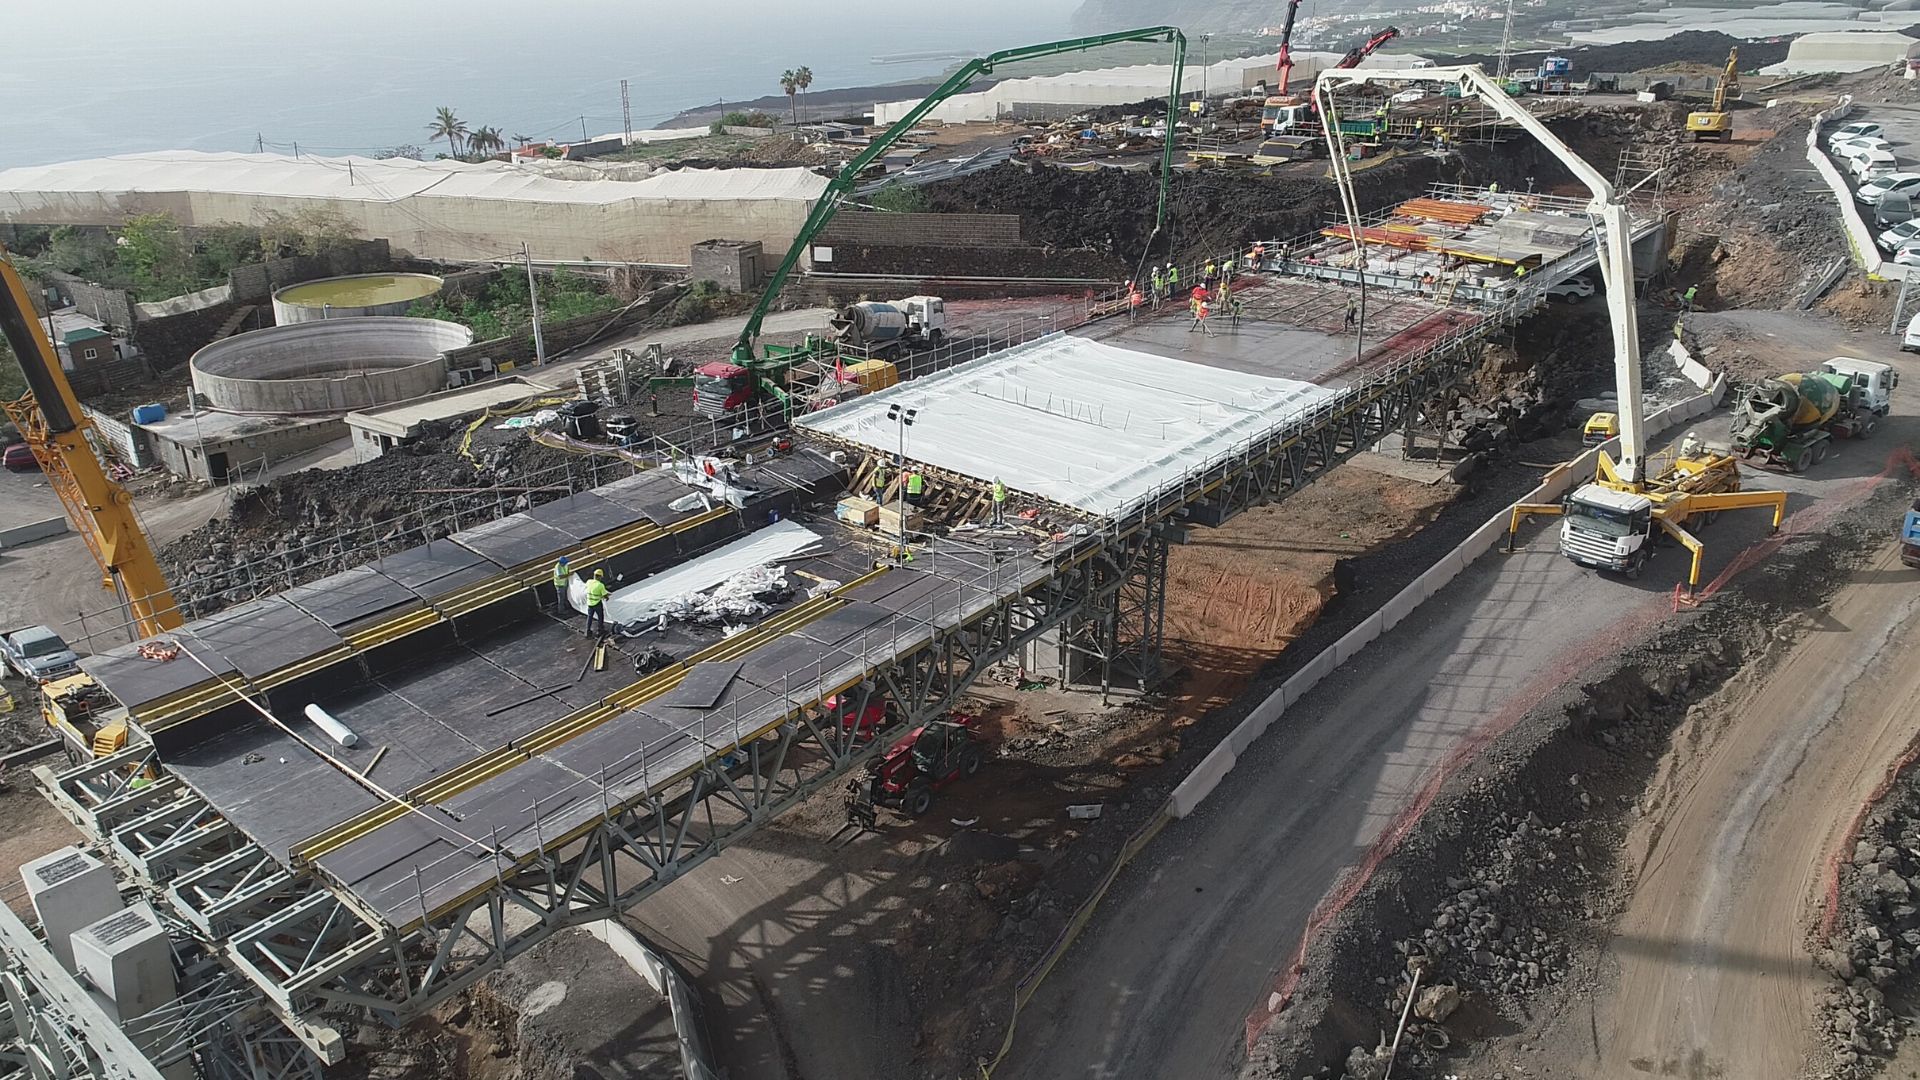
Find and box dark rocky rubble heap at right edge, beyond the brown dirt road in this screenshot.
[1814,773,1920,1078]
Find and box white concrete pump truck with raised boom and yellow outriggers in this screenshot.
[1315,65,1788,586]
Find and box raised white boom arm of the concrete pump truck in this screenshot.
[1313,65,1647,476]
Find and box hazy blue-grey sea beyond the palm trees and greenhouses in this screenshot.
[0,0,1077,167]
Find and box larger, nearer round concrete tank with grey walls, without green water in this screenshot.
[188,317,474,415]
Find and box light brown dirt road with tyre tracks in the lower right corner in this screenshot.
[1528,546,1920,1080]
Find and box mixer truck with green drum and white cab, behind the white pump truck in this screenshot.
[1730,363,1876,473]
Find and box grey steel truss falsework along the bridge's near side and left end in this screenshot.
[0,278,1530,1080]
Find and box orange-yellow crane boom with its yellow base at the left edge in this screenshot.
[0,248,180,755]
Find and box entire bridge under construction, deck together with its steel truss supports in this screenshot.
[7,184,1651,1065]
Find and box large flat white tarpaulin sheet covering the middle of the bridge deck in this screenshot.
[795,334,1332,515]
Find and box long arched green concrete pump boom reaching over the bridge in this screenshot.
[733,27,1187,367]
